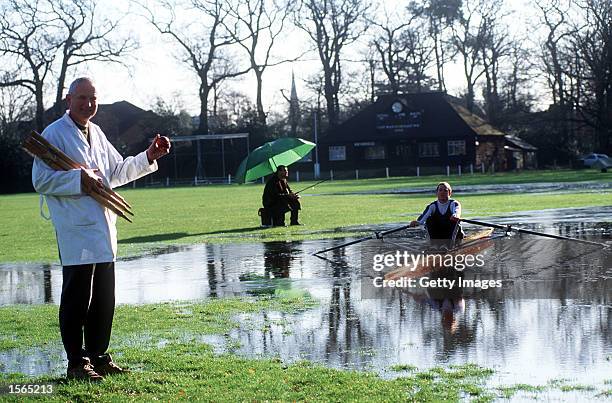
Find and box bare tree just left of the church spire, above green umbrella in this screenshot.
[223,0,297,126]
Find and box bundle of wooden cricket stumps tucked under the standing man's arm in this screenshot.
[22,131,134,222]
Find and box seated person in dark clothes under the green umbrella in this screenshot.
[261,165,301,226]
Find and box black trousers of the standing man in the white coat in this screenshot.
[59,262,115,366]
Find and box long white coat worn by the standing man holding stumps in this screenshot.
[32,112,157,266]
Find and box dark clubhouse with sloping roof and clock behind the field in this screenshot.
[319,92,533,174]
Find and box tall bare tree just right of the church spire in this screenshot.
[294,0,368,127]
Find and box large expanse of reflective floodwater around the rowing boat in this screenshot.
[0,207,612,398]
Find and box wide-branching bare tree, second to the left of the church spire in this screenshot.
[143,0,251,134]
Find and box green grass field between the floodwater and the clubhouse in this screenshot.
[0,170,612,262]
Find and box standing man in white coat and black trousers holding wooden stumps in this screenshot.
[32,78,170,381]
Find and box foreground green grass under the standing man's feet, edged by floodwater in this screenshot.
[0,296,494,401]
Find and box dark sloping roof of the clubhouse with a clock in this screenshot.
[321,92,505,144]
